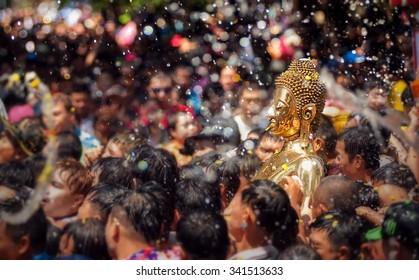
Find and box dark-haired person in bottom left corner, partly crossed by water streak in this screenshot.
[0,195,48,260]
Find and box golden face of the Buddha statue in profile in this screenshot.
[267,87,300,137]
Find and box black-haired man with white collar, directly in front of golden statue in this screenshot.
[224,180,298,259]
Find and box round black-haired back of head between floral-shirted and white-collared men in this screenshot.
[176,209,230,260]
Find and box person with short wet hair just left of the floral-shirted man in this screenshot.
[77,181,127,223]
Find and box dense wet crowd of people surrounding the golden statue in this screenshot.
[0,0,419,260]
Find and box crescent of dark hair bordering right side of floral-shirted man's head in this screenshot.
[137,181,175,243]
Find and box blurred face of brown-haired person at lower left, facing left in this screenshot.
[42,169,79,219]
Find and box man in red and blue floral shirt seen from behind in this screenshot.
[105,188,180,260]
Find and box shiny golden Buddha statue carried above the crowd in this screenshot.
[254,59,326,205]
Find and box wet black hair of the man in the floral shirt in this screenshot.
[110,188,163,244]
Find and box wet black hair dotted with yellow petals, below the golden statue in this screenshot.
[310,209,366,259]
